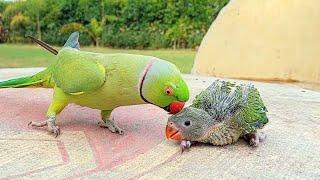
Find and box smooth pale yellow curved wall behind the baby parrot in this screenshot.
[193,0,320,83]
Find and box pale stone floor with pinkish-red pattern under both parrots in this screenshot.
[0,68,320,179]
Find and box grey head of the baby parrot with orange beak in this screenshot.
[166,107,212,141]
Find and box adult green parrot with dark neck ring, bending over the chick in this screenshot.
[0,32,189,136]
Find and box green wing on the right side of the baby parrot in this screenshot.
[236,85,268,133]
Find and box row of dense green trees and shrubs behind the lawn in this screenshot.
[0,0,229,48]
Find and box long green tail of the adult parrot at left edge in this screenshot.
[0,66,54,88]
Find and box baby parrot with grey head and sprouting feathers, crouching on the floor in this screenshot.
[166,80,268,151]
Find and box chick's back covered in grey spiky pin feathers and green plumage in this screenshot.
[192,80,268,136]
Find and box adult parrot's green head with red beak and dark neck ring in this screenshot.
[140,60,189,114]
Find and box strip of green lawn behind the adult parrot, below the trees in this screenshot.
[0,44,196,73]
